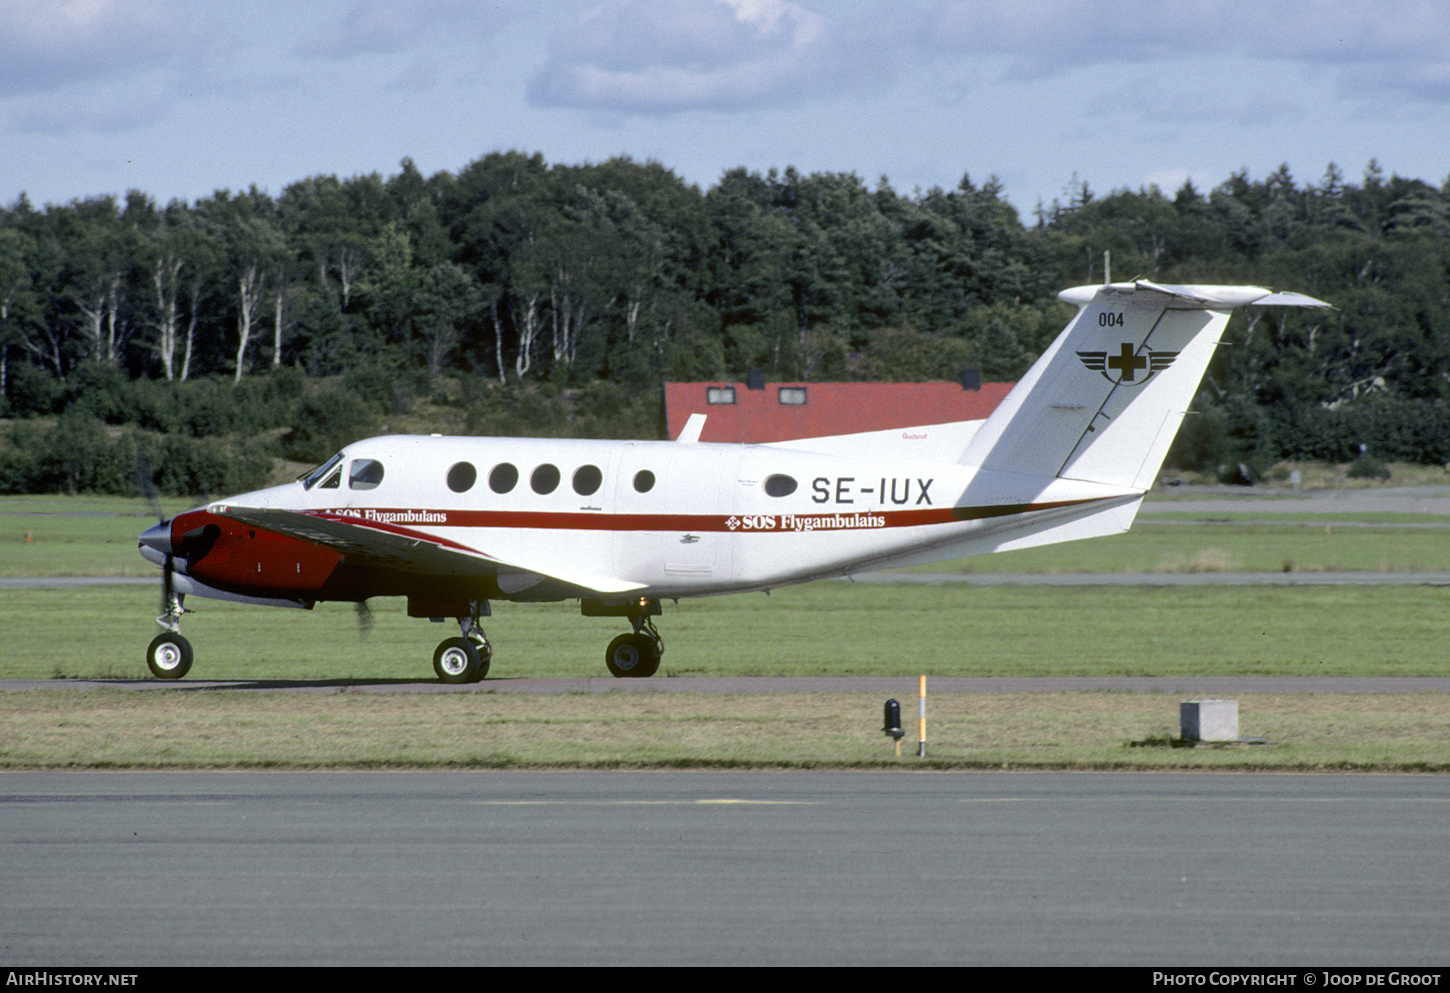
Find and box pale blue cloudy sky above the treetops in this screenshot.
[0,0,1450,219]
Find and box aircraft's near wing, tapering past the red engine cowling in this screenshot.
[207,503,644,594]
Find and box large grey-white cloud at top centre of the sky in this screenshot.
[529,0,890,113]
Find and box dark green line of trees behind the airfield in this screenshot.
[0,152,1450,484]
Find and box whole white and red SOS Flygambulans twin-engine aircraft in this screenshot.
[141,281,1328,683]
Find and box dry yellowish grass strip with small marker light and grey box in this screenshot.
[0,690,1450,771]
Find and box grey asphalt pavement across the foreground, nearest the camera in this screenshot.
[0,771,1450,968]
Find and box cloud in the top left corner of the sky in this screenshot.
[0,0,197,96]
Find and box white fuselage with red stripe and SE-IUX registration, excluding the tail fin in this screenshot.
[144,436,1141,602]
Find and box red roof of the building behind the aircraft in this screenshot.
[664,383,1015,444]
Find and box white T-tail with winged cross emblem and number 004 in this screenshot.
[960,280,1330,491]
